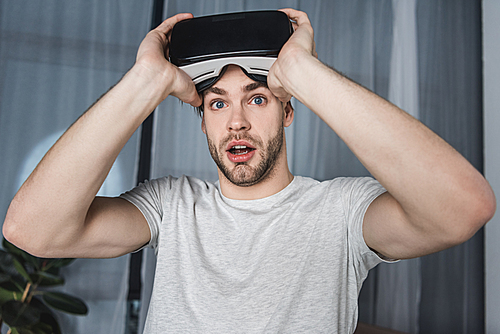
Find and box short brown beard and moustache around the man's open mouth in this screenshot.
[207,126,284,187]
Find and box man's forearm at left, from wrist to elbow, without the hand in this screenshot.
[4,68,163,253]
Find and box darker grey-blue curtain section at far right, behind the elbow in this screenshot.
[417,0,484,333]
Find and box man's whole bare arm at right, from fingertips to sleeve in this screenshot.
[268,10,496,258]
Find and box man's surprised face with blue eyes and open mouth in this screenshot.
[202,65,293,186]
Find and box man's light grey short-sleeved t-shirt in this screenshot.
[122,176,385,334]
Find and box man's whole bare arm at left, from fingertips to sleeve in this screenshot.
[3,14,201,257]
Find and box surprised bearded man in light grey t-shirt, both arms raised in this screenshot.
[3,9,496,333]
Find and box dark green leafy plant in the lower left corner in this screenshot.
[0,239,88,334]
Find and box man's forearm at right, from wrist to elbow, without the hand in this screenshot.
[289,53,494,233]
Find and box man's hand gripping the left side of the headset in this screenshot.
[133,14,202,107]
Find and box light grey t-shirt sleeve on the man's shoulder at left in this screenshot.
[120,177,172,250]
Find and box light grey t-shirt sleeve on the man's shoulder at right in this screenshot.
[341,177,392,279]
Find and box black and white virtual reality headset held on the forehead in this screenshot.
[169,11,293,92]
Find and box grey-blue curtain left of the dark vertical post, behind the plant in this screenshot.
[0,0,151,334]
